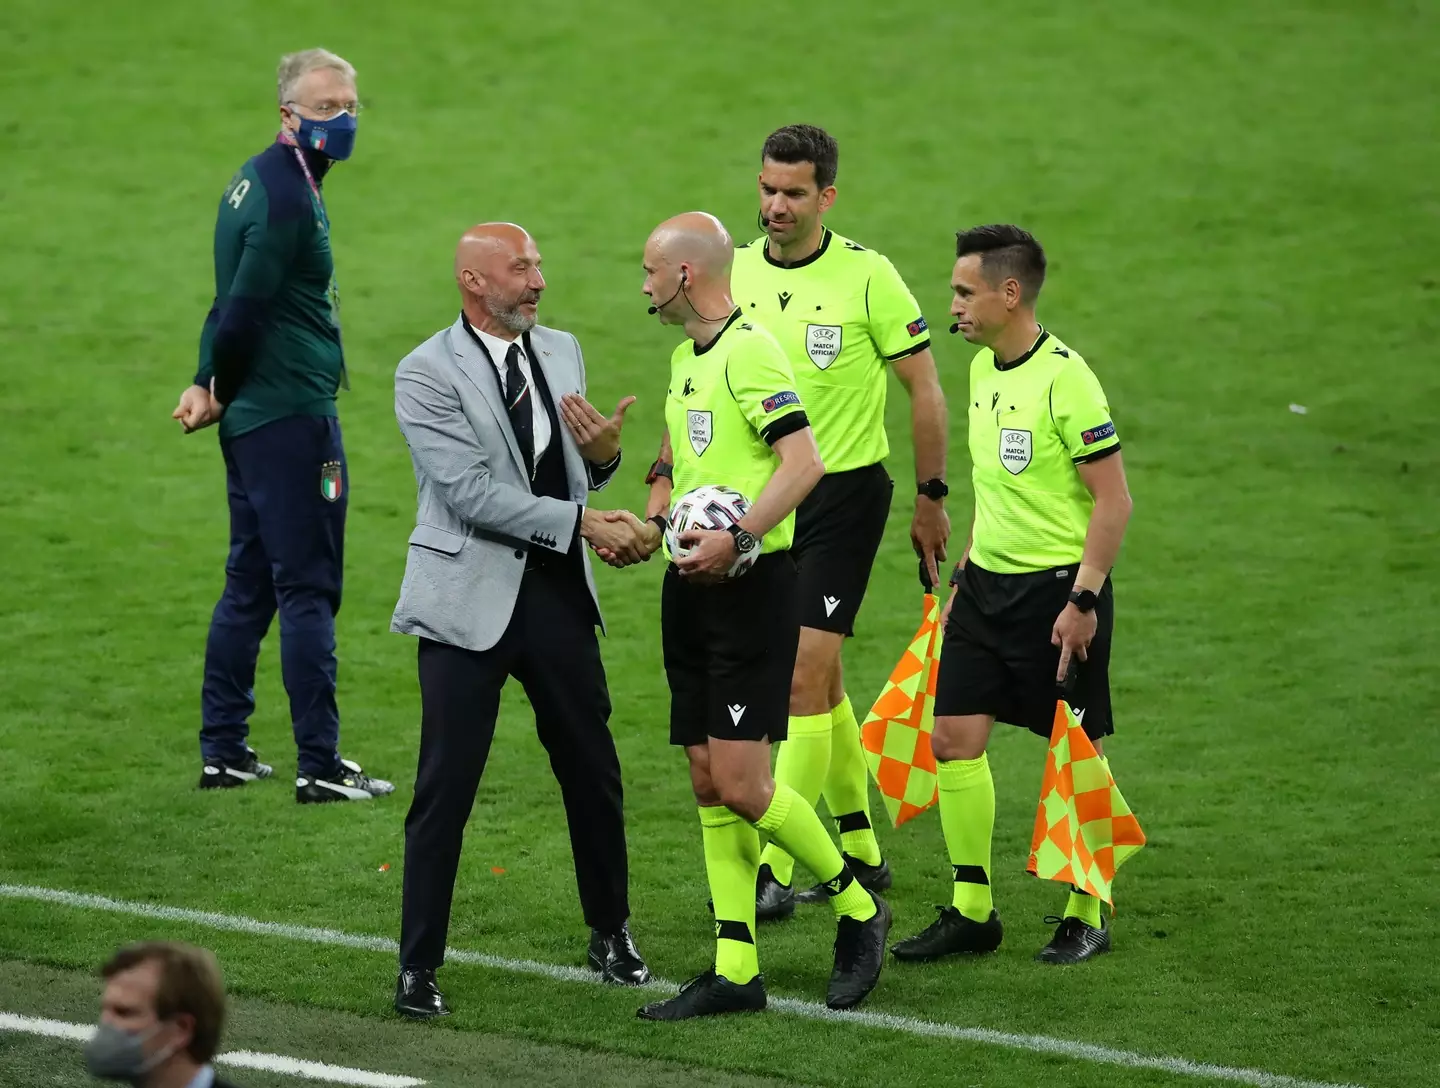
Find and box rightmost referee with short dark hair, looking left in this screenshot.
[893,226,1130,964]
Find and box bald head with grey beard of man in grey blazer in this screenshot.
[455,223,544,340]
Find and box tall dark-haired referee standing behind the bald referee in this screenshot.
[642,125,950,921]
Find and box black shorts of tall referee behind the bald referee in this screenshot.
[791,463,894,635]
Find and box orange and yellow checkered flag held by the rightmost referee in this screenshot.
[1025,699,1145,908]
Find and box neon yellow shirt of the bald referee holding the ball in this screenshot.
[665,308,809,554]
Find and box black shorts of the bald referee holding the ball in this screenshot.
[660,551,801,747]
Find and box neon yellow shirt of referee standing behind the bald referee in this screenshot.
[730,229,930,472]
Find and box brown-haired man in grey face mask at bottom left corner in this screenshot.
[85,941,233,1088]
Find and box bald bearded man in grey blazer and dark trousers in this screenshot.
[390,223,649,1019]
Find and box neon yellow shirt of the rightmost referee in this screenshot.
[969,331,1120,574]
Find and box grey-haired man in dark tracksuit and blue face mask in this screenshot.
[173,49,395,803]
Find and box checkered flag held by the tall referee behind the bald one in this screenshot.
[860,593,942,828]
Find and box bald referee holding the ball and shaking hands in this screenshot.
[602,212,890,1020]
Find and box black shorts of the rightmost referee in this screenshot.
[935,563,1115,740]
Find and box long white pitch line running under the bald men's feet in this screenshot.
[0,884,1361,1088]
